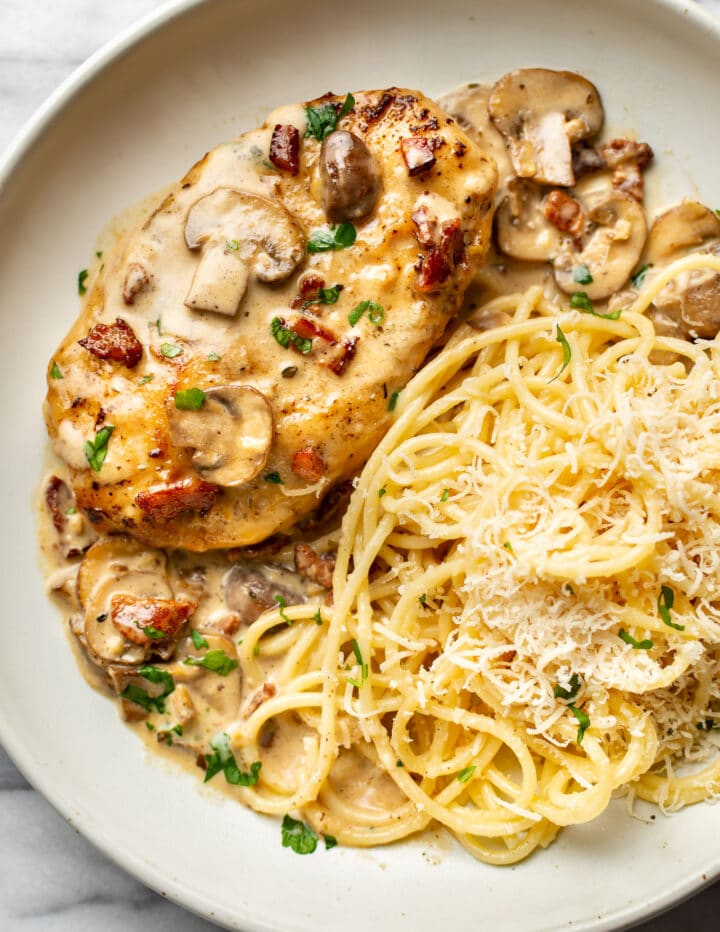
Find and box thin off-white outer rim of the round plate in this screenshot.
[0,0,720,932]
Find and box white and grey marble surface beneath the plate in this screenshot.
[0,0,720,932]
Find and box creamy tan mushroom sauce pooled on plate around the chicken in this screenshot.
[40,69,720,813]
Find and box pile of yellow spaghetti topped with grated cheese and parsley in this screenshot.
[230,254,720,864]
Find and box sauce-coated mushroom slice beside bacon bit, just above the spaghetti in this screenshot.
[554,191,647,301]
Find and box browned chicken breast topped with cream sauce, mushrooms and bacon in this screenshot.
[46,88,496,551]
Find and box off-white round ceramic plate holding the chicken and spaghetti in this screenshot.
[0,0,720,932]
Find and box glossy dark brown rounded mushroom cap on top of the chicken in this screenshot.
[320,130,380,223]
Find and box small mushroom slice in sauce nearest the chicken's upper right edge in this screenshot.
[495,178,561,262]
